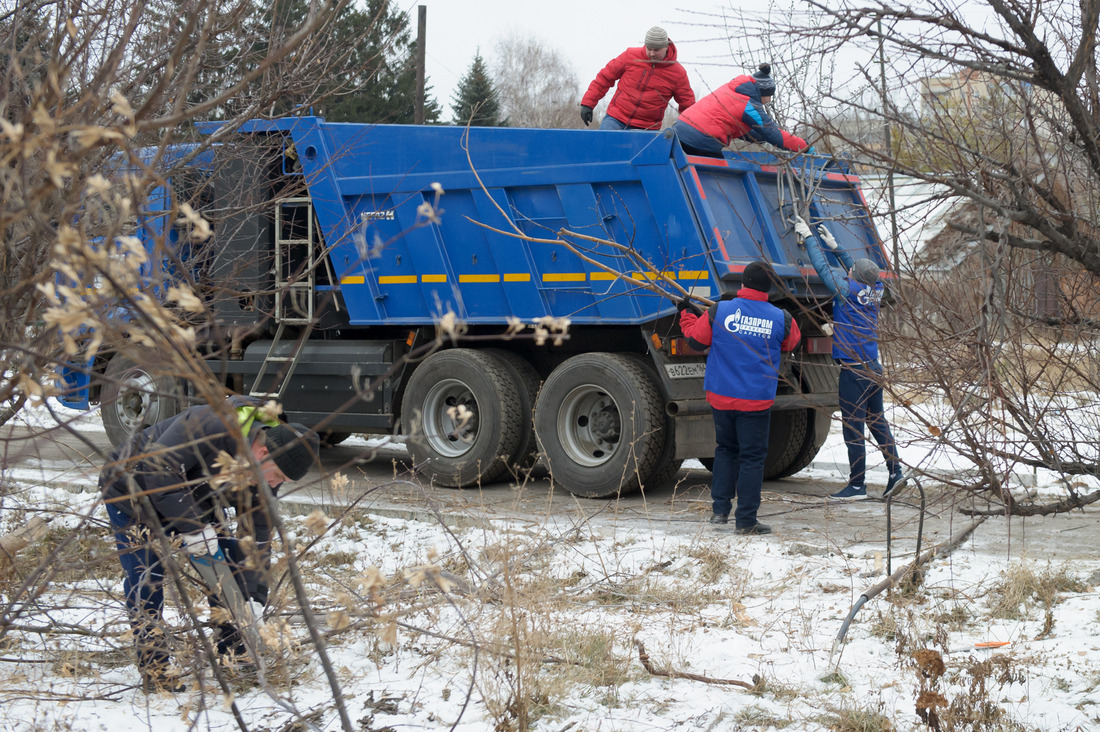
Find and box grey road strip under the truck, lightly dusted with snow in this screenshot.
[0,416,1100,559]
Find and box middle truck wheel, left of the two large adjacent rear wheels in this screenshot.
[402,348,523,488]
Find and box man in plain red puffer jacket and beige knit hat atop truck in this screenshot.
[581,25,695,130]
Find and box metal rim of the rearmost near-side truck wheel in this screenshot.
[558,384,623,468]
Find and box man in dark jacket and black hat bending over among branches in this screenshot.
[99,396,319,692]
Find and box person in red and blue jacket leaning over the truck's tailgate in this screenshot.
[672,64,814,157]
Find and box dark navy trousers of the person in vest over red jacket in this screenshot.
[711,409,771,528]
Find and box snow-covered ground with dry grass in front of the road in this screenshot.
[0,400,1100,732]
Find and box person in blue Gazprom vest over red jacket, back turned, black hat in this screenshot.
[678,261,802,534]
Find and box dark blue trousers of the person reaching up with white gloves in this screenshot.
[839,362,901,485]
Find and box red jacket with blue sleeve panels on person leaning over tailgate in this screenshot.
[679,76,810,153]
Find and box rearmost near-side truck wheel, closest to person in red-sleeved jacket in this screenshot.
[535,353,664,498]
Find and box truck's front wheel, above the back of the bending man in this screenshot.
[99,353,183,447]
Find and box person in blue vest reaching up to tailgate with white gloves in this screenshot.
[795,219,904,499]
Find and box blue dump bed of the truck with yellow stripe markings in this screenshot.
[229,118,886,326]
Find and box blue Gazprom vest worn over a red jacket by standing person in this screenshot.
[703,297,787,400]
